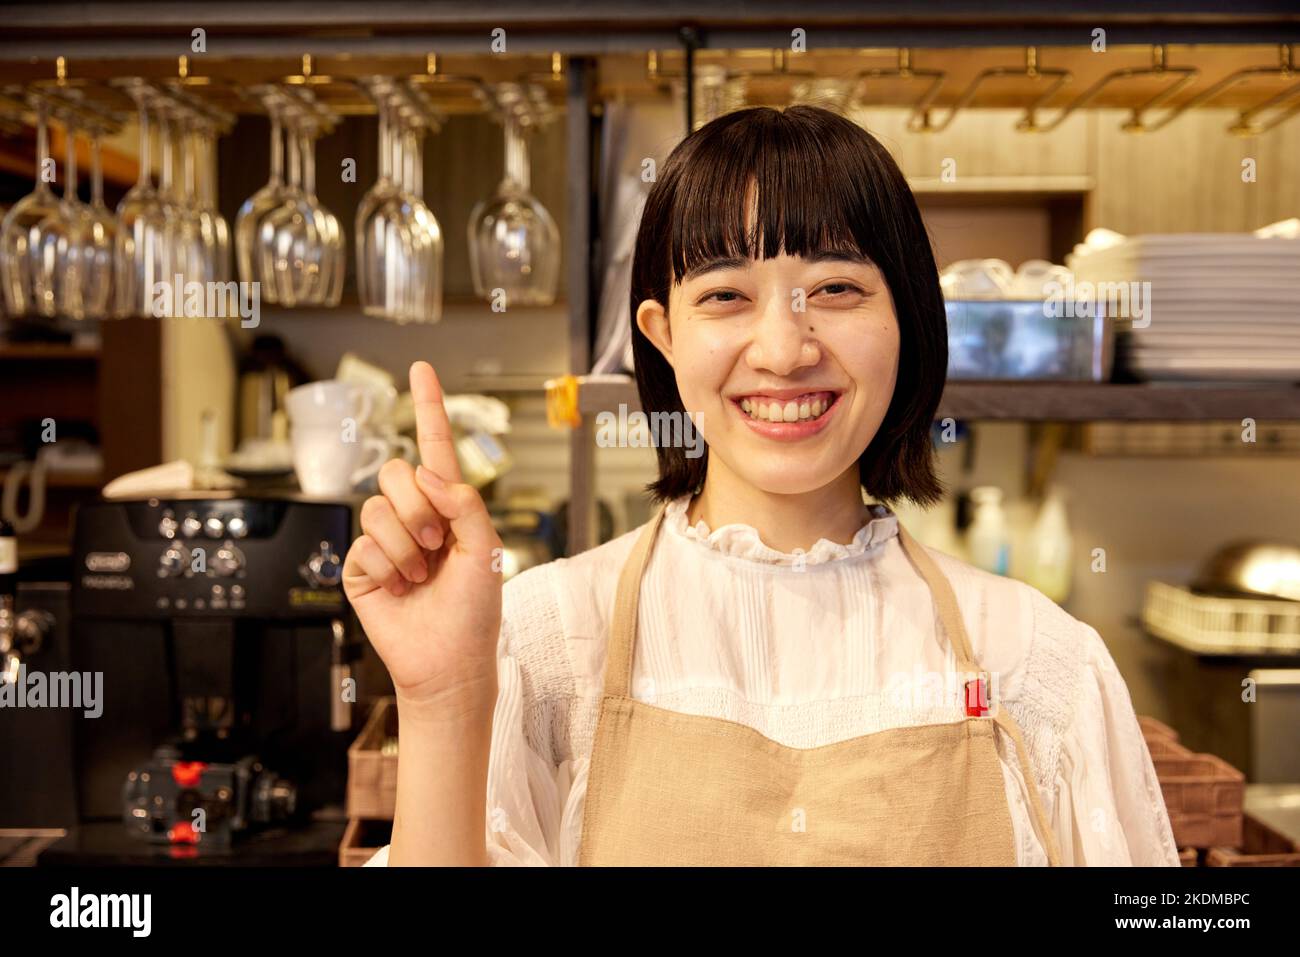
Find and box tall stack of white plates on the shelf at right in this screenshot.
[1069,233,1300,382]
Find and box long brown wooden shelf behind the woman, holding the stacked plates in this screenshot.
[579,377,1300,423]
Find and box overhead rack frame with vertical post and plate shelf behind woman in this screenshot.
[0,0,1300,553]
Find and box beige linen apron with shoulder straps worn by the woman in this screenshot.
[579,508,1060,866]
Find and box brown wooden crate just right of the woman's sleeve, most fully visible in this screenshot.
[1152,754,1245,848]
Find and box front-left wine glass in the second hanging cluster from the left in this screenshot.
[113,81,172,316]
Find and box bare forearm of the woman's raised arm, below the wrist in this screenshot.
[389,681,497,867]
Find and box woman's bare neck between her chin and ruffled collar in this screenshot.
[686,456,863,553]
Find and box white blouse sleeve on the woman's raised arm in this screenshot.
[365,566,569,867]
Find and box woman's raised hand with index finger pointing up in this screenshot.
[343,361,502,716]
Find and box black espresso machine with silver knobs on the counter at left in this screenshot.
[29,493,358,865]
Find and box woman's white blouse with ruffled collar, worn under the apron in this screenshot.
[367,497,1179,866]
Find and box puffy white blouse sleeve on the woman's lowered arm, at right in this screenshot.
[1052,623,1179,867]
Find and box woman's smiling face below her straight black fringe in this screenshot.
[637,252,898,494]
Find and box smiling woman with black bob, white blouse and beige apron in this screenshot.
[345,107,1179,866]
